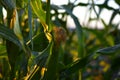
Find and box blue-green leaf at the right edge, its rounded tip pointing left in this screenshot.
[96,44,120,55]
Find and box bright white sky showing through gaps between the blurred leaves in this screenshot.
[49,0,120,29]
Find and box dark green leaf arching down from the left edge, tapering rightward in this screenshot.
[0,24,21,48]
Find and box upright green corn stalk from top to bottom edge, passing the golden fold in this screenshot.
[42,0,59,80]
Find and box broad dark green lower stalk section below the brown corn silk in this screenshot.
[42,44,59,80]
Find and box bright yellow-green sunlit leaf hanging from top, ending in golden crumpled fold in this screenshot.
[31,0,52,42]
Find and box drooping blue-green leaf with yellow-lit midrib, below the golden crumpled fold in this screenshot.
[26,42,52,80]
